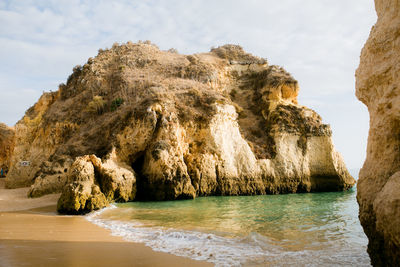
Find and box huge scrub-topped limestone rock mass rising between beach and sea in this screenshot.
[2,42,354,213]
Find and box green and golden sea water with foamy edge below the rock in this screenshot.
[87,186,370,266]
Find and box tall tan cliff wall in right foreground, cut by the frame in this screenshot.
[356,0,400,266]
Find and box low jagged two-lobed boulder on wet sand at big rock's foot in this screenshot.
[57,153,136,214]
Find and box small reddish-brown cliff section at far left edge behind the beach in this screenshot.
[0,123,14,175]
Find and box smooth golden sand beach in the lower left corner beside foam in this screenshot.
[0,179,211,267]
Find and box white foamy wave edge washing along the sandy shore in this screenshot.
[86,209,369,266]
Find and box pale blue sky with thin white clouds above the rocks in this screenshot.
[0,0,376,169]
